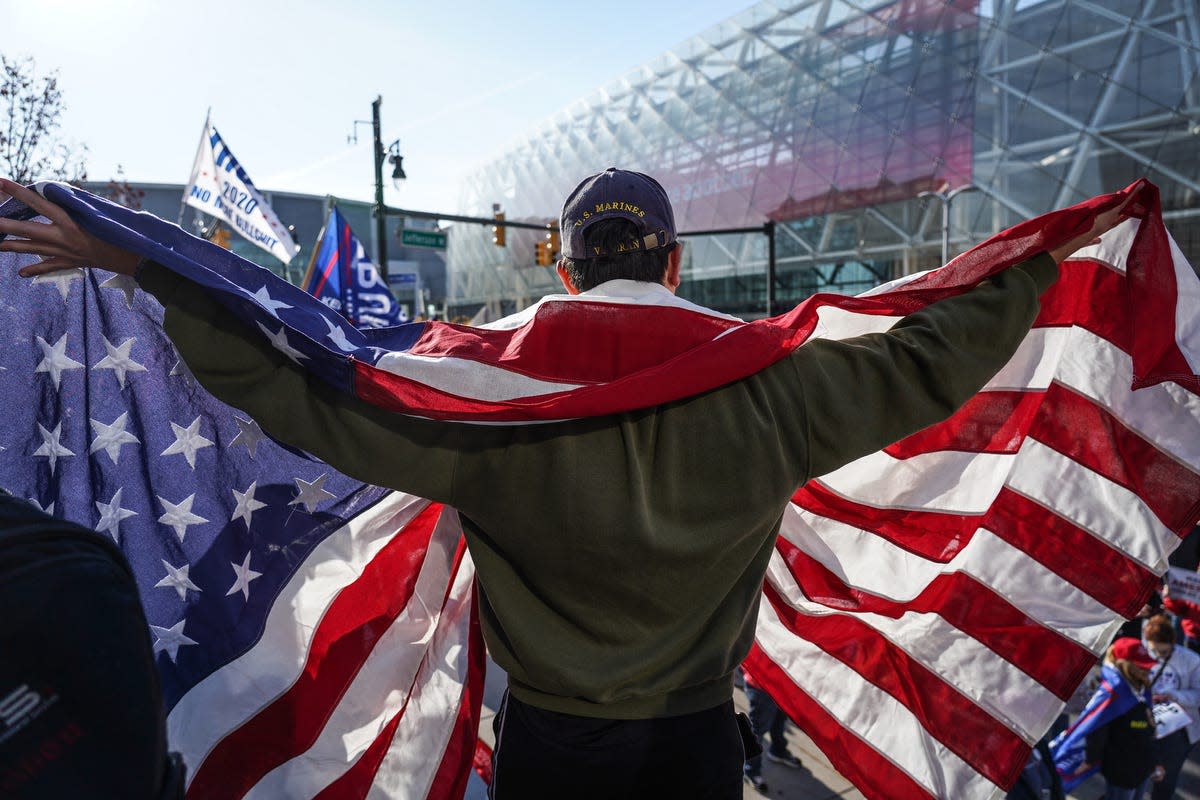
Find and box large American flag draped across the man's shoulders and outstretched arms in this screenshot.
[0,182,1200,799]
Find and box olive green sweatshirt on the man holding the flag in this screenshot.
[138,255,1057,718]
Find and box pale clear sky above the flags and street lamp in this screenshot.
[9,0,752,211]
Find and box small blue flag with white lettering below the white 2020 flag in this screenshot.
[301,206,408,327]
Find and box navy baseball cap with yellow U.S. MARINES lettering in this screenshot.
[559,167,676,260]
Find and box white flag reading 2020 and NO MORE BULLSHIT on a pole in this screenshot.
[184,118,300,264]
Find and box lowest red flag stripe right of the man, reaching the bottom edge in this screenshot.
[745,644,935,800]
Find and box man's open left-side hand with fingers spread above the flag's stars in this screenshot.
[0,178,139,278]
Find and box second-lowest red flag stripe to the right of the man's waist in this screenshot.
[764,585,1030,786]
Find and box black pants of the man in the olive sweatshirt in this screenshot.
[488,693,745,800]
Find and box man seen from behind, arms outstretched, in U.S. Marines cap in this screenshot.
[0,169,1123,800]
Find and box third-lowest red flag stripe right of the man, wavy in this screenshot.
[775,537,1096,700]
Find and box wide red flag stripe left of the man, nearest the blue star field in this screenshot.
[188,503,442,800]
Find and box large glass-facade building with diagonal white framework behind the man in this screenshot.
[448,0,1200,317]
